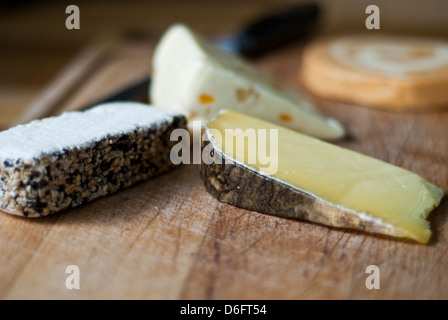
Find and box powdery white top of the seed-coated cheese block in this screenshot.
[0,102,175,160]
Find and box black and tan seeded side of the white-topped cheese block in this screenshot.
[0,115,186,217]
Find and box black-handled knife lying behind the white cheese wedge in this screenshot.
[81,3,321,110]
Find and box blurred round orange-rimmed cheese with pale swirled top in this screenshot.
[301,36,448,110]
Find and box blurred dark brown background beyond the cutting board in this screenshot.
[0,0,448,128]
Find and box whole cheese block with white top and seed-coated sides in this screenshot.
[0,102,186,217]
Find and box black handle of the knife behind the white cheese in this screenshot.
[234,3,321,58]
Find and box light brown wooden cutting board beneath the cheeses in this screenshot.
[0,38,448,299]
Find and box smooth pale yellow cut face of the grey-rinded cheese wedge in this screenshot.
[207,110,444,243]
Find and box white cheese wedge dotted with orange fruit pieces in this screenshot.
[150,24,344,140]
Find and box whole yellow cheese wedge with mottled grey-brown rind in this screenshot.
[201,110,444,243]
